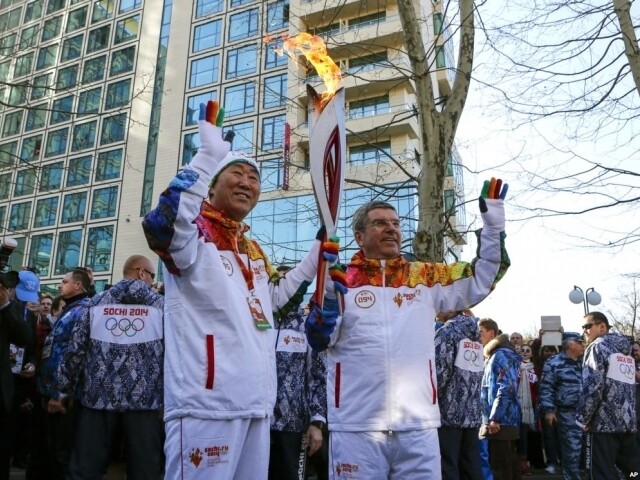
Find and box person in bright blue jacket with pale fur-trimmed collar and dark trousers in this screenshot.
[479,330,522,480]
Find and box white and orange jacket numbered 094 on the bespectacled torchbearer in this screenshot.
[327,228,509,432]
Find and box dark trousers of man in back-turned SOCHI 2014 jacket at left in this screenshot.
[69,407,164,480]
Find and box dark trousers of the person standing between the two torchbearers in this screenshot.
[269,430,306,480]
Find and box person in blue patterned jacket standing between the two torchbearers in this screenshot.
[269,292,327,480]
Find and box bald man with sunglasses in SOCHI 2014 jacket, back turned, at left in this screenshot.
[57,255,164,480]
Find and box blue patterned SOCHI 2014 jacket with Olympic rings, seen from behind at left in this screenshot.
[57,280,164,412]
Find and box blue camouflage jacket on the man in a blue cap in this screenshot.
[539,352,582,414]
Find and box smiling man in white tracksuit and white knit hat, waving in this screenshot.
[143,102,320,480]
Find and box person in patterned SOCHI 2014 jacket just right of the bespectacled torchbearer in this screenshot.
[435,310,484,480]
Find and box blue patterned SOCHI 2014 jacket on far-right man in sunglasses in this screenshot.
[576,333,637,433]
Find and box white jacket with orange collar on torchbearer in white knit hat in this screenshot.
[143,138,320,421]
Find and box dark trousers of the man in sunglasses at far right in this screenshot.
[587,433,640,480]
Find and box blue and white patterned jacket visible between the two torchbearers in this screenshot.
[271,309,327,432]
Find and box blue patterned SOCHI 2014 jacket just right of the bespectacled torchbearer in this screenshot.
[435,314,484,428]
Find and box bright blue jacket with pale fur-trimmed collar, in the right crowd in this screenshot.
[481,334,522,427]
